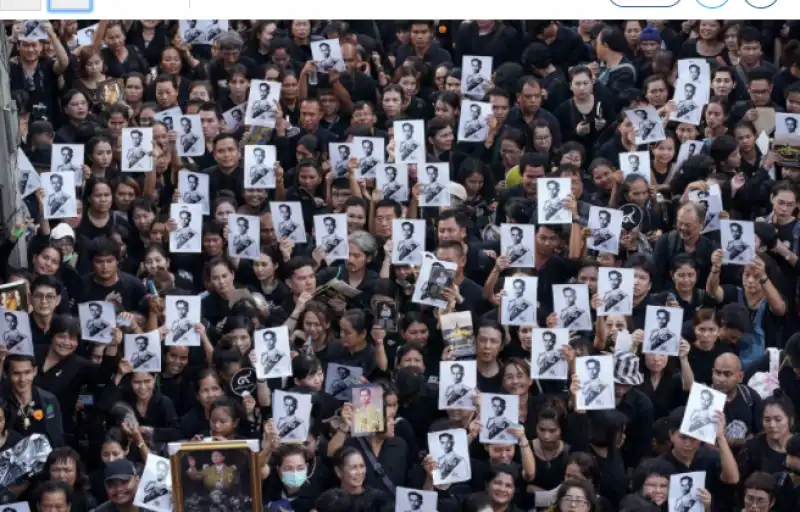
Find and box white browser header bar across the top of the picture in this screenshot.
[0,0,798,20]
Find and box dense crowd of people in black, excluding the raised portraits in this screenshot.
[0,20,800,512]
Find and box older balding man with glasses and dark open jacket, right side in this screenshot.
[653,201,719,290]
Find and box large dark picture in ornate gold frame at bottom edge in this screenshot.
[169,440,263,512]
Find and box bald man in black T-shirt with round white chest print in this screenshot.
[711,353,762,449]
